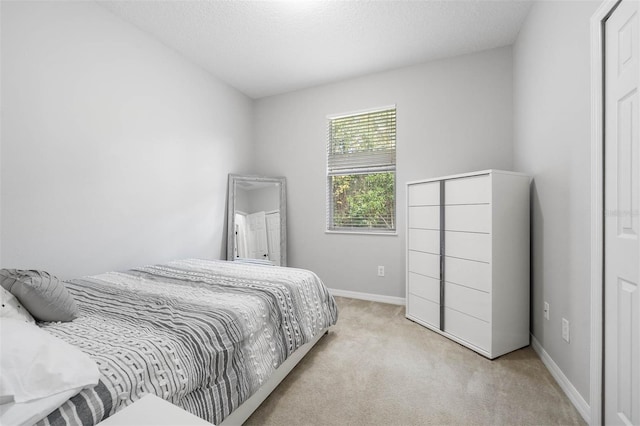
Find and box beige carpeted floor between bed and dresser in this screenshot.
[245,298,585,425]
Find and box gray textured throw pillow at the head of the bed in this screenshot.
[0,269,78,321]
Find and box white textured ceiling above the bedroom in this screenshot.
[99,0,531,98]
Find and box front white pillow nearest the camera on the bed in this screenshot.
[0,318,100,408]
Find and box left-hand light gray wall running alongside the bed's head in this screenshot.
[0,2,252,278]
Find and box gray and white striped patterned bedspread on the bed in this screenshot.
[39,260,338,425]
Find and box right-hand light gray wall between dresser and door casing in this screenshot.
[514,1,600,403]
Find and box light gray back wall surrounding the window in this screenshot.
[254,47,513,297]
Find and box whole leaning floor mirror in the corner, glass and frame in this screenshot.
[227,174,287,266]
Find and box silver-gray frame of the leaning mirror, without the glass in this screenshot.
[227,173,287,266]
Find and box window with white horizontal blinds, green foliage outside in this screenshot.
[327,106,396,233]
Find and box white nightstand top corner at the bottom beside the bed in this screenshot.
[99,394,211,426]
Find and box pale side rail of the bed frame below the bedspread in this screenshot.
[219,328,329,426]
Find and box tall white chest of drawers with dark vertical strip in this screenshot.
[406,170,530,359]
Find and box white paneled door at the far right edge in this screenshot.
[603,0,640,425]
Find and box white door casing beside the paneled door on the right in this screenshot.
[589,0,622,425]
